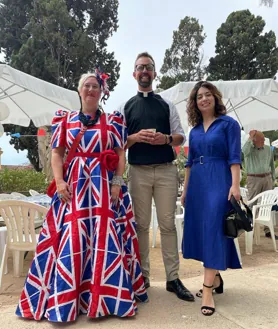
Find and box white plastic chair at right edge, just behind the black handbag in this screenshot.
[245,190,278,255]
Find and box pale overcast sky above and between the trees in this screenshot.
[0,0,278,164]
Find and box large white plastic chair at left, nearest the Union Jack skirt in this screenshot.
[0,200,48,289]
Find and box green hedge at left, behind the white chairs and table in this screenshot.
[0,169,48,195]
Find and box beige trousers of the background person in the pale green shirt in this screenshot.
[247,175,273,233]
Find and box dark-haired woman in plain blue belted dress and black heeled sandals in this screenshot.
[181,81,241,316]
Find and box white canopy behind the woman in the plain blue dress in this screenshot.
[160,79,278,133]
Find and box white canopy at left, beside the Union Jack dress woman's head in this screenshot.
[0,64,80,127]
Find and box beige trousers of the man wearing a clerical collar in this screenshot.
[129,163,179,281]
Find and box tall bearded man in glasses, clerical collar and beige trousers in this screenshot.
[121,52,194,301]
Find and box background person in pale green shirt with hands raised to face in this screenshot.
[242,130,278,240]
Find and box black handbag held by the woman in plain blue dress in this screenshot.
[224,196,253,239]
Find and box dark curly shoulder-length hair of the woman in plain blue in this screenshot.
[186,81,227,127]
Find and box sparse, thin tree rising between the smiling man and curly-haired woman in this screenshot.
[158,16,206,89]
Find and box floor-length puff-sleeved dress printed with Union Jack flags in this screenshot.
[16,111,148,322]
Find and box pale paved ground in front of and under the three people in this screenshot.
[0,259,278,329]
